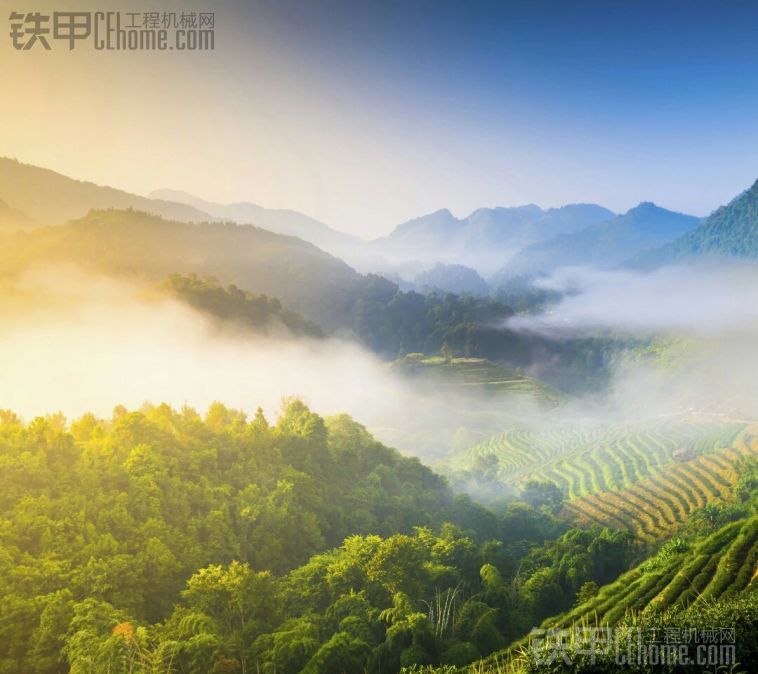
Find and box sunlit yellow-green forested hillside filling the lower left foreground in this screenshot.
[0,401,568,674]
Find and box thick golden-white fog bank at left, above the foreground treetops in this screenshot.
[0,268,548,456]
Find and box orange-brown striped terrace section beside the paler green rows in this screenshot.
[564,432,758,540]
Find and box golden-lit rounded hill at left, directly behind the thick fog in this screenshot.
[0,210,382,328]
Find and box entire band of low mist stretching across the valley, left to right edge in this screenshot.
[0,265,758,470]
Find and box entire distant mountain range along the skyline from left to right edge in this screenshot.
[0,158,758,292]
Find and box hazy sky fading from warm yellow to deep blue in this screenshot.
[0,0,758,237]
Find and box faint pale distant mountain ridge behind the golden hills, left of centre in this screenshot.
[150,189,363,255]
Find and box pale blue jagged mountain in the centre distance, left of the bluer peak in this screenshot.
[373,204,614,273]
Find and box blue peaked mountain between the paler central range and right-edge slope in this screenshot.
[490,202,700,286]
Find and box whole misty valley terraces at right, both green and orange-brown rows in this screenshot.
[442,419,758,540]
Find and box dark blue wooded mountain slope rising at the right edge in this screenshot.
[630,180,758,267]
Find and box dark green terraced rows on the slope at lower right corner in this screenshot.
[545,517,758,627]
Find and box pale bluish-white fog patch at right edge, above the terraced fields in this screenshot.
[507,261,758,420]
